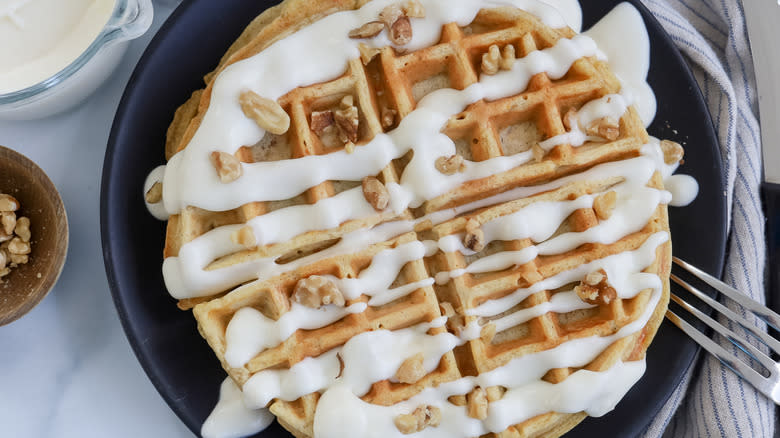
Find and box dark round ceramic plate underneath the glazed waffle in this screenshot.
[101,0,726,437]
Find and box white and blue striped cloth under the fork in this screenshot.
[642,0,780,438]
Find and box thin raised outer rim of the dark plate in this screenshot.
[100,0,728,436]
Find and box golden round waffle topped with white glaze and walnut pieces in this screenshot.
[151,0,680,437]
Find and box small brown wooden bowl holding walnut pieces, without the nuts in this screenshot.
[0,146,68,326]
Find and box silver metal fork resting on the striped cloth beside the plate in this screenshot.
[666,257,780,405]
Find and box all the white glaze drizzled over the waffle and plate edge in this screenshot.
[145,0,695,437]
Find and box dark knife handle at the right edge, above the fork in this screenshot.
[761,182,780,313]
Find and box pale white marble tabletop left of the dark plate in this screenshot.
[0,0,193,438]
